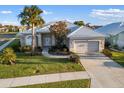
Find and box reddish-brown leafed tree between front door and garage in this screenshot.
[49,21,69,47]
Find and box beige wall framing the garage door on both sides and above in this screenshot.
[69,38,105,52]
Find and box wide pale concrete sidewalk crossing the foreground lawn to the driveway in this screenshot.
[0,71,90,88]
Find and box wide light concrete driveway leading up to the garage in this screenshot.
[81,54,124,88]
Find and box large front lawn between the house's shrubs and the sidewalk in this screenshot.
[0,54,85,78]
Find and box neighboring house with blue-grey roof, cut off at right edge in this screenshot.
[95,22,124,48]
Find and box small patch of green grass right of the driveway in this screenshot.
[111,51,124,67]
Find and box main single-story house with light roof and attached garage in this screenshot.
[20,21,104,53]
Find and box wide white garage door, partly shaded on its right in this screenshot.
[75,41,99,53]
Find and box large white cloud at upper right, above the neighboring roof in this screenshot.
[90,9,124,22]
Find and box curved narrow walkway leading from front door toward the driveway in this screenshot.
[42,47,69,58]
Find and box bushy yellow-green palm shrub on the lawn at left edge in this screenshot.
[0,48,16,65]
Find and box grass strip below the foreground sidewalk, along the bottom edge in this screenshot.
[15,79,90,88]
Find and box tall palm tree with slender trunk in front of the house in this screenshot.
[18,5,45,55]
